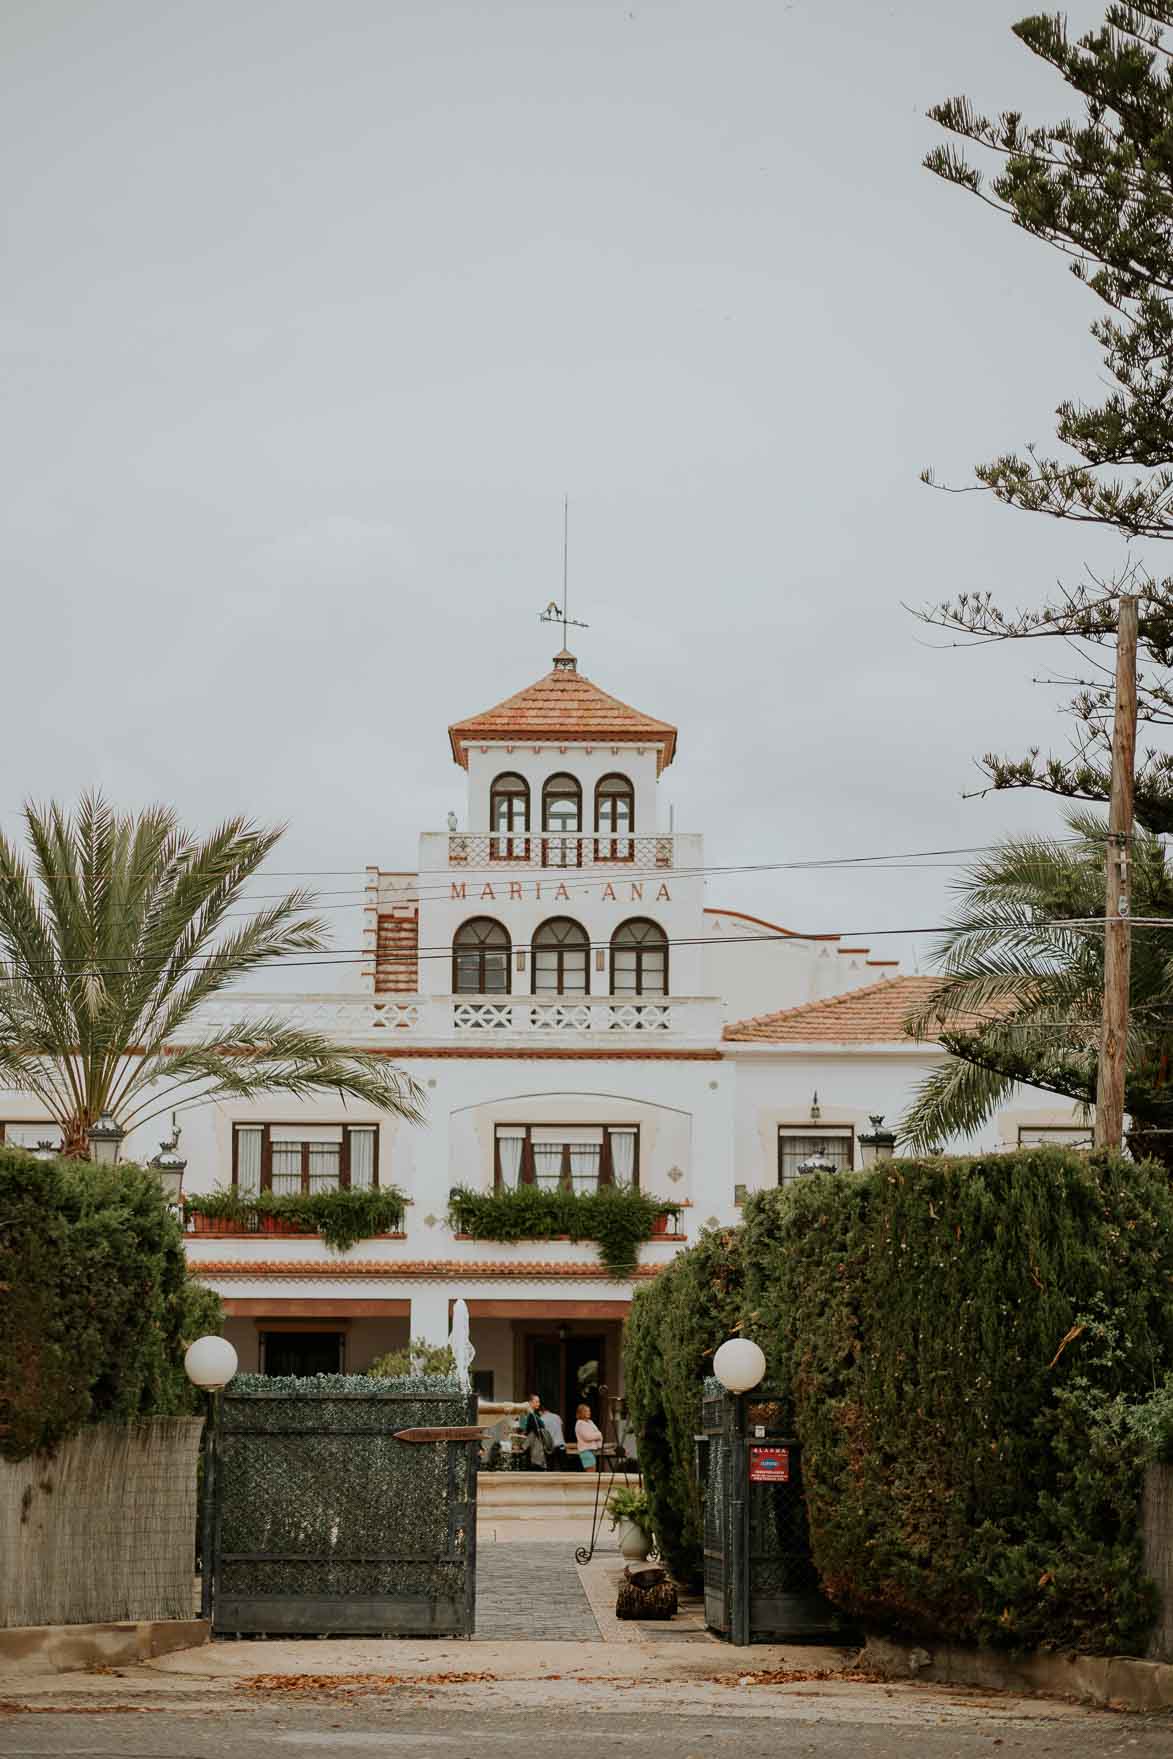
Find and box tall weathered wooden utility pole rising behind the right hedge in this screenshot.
[1096,595,1136,1150]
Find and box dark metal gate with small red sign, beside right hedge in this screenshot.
[696,1381,844,1643]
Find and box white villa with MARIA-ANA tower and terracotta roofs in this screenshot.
[0,651,1083,1412]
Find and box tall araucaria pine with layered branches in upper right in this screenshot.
[923,0,1173,832]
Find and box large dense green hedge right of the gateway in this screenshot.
[628,1149,1173,1652]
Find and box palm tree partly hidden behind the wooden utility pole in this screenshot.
[902,813,1173,1164]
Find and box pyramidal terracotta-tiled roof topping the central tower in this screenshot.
[448,656,675,770]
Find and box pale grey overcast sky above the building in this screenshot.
[0,0,1124,982]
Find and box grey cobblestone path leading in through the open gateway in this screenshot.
[475,1539,600,1643]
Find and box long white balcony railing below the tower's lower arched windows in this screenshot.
[178,992,721,1050]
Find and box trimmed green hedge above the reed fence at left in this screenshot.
[0,1147,222,1460]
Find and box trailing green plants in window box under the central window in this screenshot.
[448,1186,679,1277]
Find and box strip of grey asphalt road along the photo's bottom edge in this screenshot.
[0,1692,1173,1759]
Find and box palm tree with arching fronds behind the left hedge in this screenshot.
[0,795,422,1156]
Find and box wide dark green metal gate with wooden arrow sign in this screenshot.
[204,1376,478,1636]
